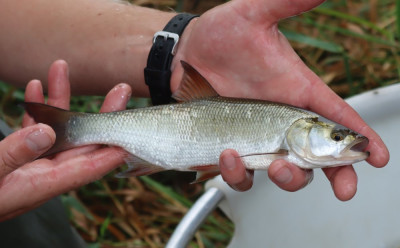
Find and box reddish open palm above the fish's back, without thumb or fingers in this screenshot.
[173,1,326,104]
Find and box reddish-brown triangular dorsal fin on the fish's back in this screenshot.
[172,60,218,102]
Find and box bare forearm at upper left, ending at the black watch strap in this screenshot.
[0,0,174,96]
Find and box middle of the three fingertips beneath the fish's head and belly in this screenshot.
[268,159,314,192]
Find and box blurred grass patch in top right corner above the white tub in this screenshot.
[281,1,399,97]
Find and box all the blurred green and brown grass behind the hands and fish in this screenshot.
[0,0,400,248]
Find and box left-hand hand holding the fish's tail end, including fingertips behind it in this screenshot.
[0,61,131,221]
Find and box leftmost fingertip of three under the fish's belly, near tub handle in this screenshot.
[219,149,254,191]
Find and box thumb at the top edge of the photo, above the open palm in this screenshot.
[232,0,325,24]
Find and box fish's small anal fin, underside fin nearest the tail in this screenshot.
[115,154,165,178]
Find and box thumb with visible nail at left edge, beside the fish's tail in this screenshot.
[0,124,56,178]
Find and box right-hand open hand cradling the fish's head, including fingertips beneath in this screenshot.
[171,0,389,200]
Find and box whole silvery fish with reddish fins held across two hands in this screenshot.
[24,61,369,182]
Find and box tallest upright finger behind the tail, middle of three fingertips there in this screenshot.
[47,60,71,109]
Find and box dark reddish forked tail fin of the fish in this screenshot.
[23,102,81,157]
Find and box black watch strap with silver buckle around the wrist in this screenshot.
[144,13,197,105]
